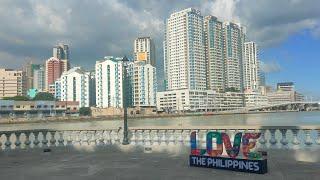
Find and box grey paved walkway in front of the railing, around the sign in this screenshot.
[0,146,320,180]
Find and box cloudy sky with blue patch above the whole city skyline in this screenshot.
[0,0,320,99]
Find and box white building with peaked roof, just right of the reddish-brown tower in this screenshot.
[60,67,90,107]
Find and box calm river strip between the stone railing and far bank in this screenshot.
[0,111,320,131]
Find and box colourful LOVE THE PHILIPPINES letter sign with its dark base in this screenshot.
[189,131,268,174]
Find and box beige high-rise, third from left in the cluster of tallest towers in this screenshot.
[224,22,245,91]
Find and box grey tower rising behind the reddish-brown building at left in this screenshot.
[52,43,70,72]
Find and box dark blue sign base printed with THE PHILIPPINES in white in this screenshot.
[189,155,268,174]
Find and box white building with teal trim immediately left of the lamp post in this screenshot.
[95,56,124,108]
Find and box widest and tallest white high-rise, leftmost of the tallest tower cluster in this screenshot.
[164,8,207,90]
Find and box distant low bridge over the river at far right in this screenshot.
[246,101,320,111]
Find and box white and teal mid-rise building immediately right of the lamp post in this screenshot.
[128,62,157,107]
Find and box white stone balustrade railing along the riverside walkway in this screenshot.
[0,126,320,150]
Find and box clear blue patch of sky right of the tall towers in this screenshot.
[260,31,320,98]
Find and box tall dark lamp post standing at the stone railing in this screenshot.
[122,57,129,145]
